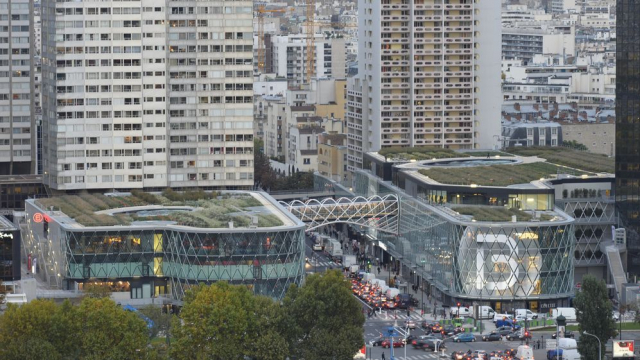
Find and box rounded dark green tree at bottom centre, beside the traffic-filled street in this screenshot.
[283,270,364,360]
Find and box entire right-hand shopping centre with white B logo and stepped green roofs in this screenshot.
[355,150,625,312]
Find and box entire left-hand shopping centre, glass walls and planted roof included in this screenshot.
[23,191,305,301]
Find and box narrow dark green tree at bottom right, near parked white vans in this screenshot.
[573,275,616,359]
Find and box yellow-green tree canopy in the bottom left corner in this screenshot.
[0,298,149,360]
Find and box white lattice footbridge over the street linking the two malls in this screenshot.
[281,194,399,234]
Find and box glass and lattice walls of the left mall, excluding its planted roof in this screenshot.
[24,194,305,300]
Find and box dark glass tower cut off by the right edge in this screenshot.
[615,0,640,274]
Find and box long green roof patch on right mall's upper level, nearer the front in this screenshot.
[420,162,584,186]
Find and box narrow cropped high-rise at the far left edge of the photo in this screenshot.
[0,0,36,175]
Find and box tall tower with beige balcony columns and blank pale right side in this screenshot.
[347,0,501,170]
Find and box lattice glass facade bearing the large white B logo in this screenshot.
[356,171,575,309]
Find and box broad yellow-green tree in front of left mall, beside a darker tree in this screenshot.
[171,281,286,360]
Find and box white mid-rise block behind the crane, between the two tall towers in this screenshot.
[272,34,346,86]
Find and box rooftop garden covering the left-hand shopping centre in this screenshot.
[38,189,283,228]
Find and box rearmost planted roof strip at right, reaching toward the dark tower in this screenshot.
[506,146,615,173]
